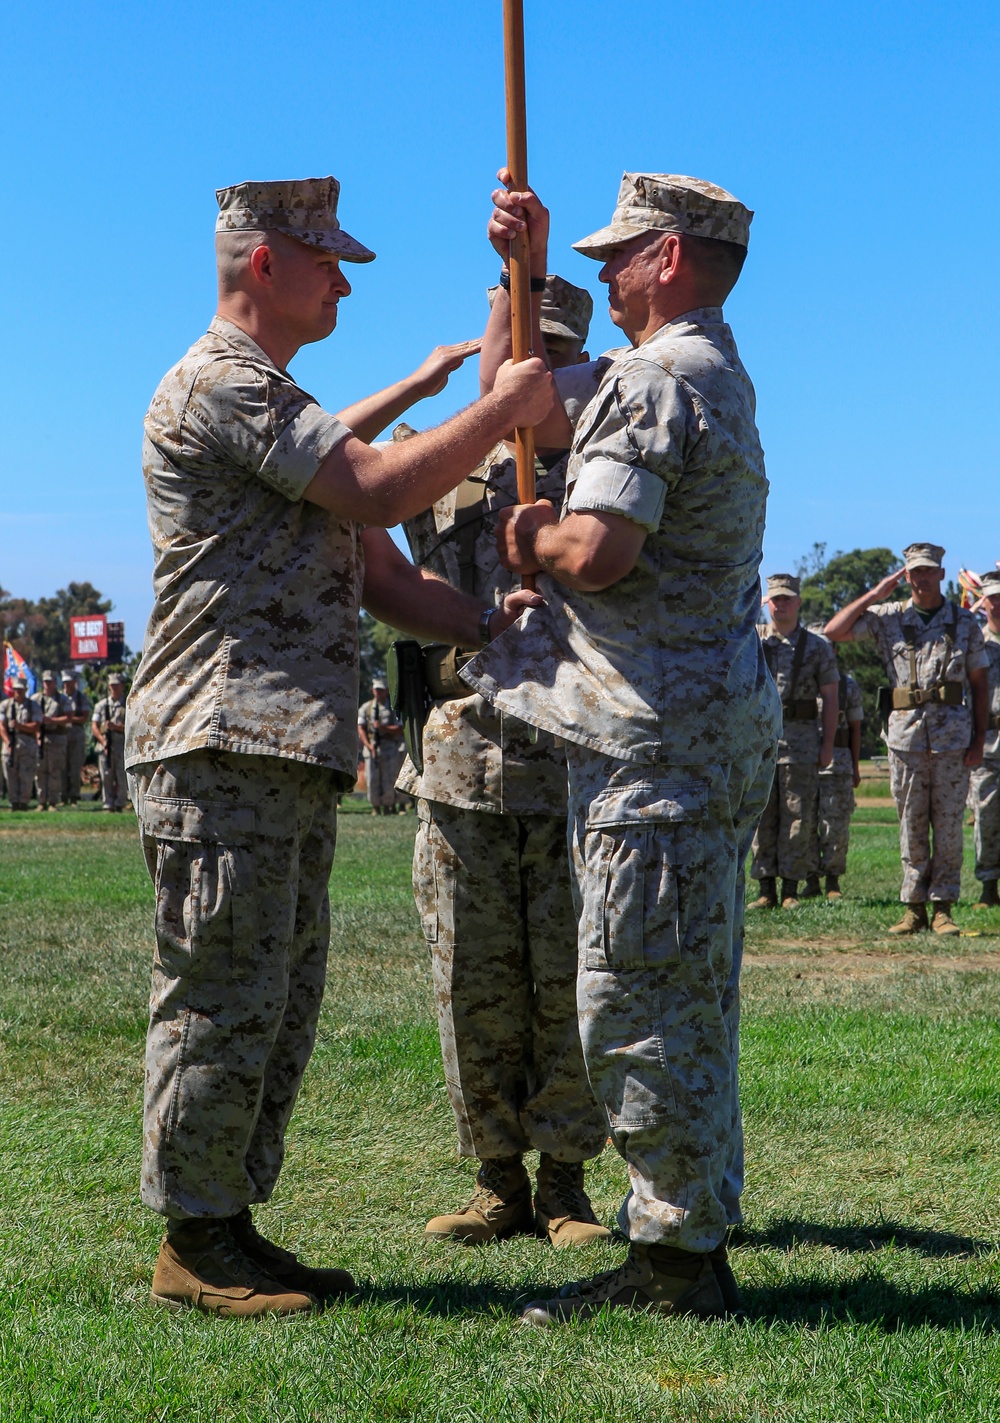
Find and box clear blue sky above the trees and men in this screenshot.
[0,0,1000,646]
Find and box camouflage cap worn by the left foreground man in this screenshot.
[215,178,376,262]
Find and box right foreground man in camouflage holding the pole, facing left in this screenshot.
[462,171,780,1323]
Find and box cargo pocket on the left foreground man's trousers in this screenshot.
[142,795,257,982]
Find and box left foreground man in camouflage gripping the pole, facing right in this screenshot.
[127,178,552,1315]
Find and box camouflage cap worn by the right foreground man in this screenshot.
[573,174,754,262]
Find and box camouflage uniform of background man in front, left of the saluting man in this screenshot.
[750,623,838,879]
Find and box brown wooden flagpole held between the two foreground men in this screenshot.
[504,0,535,588]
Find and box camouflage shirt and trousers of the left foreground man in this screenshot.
[127,317,363,1218]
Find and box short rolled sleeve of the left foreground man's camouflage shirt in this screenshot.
[183,360,351,502]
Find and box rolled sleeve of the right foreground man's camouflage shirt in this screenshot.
[566,360,701,532]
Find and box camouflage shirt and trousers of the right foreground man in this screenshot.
[462,305,780,1252]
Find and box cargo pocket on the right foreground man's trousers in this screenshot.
[583,784,707,972]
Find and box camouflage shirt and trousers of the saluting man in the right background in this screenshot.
[851,602,989,904]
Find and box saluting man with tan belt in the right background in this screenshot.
[825,544,990,935]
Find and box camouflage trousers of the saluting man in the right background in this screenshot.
[889,747,969,904]
